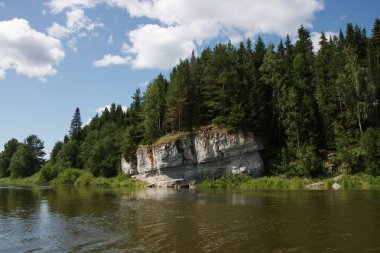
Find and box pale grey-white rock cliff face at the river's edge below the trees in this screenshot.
[122,127,264,186]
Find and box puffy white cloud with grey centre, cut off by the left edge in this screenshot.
[0,18,65,80]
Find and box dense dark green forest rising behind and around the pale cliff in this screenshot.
[0,19,380,181]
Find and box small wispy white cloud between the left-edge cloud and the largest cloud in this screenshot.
[47,9,104,38]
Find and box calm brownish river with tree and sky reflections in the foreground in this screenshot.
[0,187,380,253]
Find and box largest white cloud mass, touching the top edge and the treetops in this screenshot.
[49,0,324,69]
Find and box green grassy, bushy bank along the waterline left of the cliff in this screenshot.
[0,169,145,187]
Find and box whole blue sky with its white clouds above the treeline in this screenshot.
[0,0,380,153]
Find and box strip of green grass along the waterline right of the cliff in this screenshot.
[197,175,380,190]
